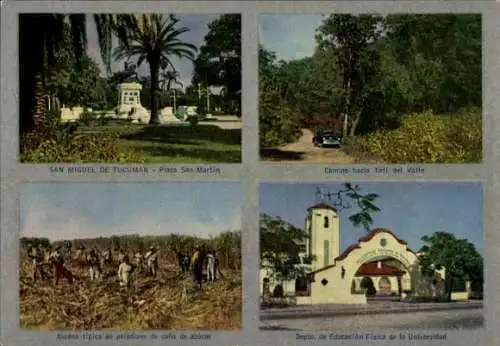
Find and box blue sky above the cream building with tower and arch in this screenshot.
[260,181,484,255]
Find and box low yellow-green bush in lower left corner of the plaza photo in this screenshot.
[21,133,144,163]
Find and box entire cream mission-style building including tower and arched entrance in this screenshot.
[260,203,467,304]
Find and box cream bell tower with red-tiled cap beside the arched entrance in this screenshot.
[306,202,340,271]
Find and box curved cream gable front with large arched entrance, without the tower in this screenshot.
[309,229,420,304]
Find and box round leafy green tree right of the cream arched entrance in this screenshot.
[420,231,483,300]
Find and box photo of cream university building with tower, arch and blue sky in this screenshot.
[260,181,484,332]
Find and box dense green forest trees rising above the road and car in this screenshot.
[259,14,482,147]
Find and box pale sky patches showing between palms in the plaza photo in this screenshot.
[87,14,220,88]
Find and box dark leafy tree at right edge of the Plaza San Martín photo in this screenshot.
[192,14,241,114]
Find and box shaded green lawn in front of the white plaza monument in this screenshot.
[78,124,241,163]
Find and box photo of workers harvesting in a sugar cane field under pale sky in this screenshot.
[19,182,242,331]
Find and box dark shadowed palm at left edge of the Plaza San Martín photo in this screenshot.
[19,13,123,140]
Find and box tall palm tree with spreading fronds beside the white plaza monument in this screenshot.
[114,14,197,125]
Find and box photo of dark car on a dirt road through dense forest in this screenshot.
[259,13,483,164]
